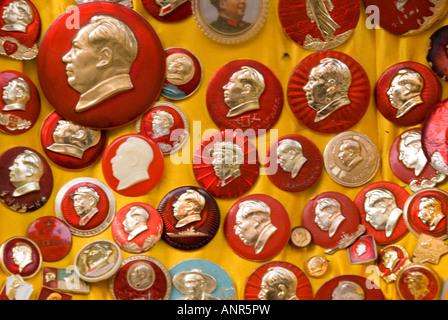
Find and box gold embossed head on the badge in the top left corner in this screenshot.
[2,0,34,33]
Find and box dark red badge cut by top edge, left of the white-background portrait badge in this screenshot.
[142,0,192,23]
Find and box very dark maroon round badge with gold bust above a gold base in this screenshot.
[158,187,221,250]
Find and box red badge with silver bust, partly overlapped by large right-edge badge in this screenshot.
[389,128,446,192]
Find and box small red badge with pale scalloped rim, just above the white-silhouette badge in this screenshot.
[137,101,189,155]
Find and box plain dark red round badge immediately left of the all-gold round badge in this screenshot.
[265,134,323,192]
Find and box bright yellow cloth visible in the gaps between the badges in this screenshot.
[0,0,448,300]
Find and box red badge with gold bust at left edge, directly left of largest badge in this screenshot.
[0,70,40,135]
